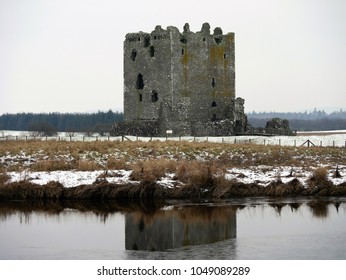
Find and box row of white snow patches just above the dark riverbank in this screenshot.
[7,165,346,188]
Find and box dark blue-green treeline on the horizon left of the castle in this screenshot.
[0,110,124,133]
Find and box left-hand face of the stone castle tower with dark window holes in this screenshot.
[124,27,171,121]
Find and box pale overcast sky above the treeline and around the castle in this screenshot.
[0,0,346,114]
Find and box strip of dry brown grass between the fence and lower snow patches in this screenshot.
[0,141,346,174]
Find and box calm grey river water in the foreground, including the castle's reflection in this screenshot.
[0,198,346,260]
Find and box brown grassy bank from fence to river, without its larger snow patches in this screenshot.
[0,141,346,199]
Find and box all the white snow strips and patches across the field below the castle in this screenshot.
[0,131,346,188]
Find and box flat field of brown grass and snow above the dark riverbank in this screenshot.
[0,141,346,197]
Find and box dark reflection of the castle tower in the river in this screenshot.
[125,205,237,251]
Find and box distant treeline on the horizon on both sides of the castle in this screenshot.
[0,110,346,135]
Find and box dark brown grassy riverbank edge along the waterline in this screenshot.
[0,178,346,201]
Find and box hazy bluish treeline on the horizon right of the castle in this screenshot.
[247,110,346,131]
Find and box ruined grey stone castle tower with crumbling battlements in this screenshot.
[113,23,292,136]
